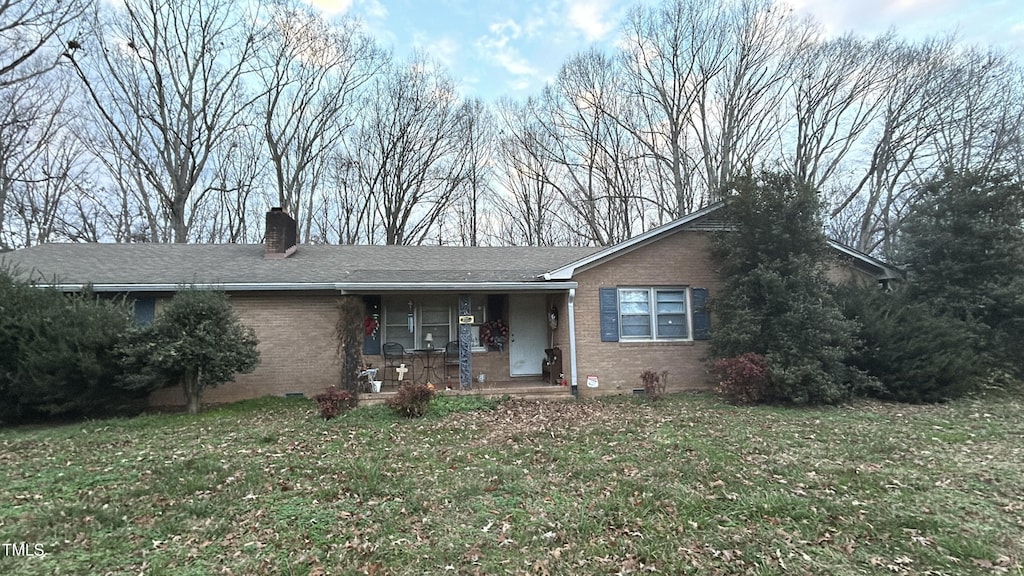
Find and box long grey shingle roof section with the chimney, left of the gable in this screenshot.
[0,244,599,287]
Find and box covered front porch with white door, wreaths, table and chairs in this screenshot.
[358,283,569,395]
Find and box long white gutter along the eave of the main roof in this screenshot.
[37,282,578,293]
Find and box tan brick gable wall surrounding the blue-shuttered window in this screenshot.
[563,231,721,396]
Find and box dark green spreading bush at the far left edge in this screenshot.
[0,269,144,422]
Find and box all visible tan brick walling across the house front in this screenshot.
[151,231,888,406]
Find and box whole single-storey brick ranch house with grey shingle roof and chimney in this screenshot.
[4,203,899,406]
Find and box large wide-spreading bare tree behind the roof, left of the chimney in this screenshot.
[66,0,260,242]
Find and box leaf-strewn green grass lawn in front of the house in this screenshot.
[0,395,1024,575]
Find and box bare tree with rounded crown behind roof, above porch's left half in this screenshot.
[349,54,466,245]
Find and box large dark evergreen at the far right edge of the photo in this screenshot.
[897,170,1024,379]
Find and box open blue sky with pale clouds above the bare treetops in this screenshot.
[308,0,1024,100]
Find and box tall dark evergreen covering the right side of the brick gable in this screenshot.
[711,172,858,404]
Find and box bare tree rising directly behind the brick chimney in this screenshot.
[260,0,385,242]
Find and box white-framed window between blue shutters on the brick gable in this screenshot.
[618,287,690,340]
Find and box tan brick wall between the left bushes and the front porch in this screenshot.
[150,292,341,406]
